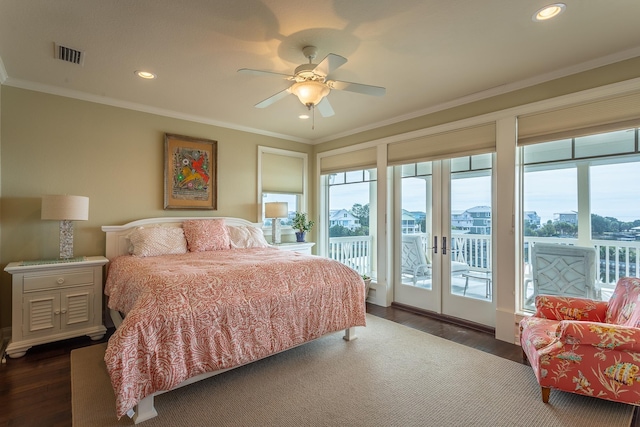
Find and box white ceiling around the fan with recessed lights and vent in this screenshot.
[0,0,640,143]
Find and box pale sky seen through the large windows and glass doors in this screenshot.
[331,163,640,224]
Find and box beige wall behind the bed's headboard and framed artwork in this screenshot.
[0,86,312,327]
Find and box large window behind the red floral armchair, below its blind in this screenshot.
[520,129,640,310]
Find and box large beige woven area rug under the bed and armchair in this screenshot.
[71,315,633,427]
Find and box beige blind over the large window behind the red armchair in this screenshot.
[518,92,640,145]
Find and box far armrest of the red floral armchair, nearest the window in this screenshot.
[534,295,608,322]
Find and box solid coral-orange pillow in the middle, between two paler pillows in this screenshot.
[182,219,231,252]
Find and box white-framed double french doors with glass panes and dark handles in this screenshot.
[394,154,495,327]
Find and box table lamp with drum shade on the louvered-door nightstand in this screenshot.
[41,195,89,259]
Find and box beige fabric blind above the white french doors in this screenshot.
[387,123,496,165]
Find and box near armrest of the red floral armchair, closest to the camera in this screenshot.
[558,320,640,353]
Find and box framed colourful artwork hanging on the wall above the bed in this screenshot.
[164,133,218,210]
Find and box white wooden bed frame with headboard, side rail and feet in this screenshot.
[102,217,357,424]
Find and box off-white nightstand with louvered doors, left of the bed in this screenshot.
[4,256,109,358]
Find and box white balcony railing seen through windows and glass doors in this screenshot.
[329,232,640,284]
